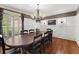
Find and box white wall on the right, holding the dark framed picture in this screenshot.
[41,16,76,40]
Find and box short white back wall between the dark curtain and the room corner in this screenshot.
[24,18,40,30]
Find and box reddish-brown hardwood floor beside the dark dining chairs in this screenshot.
[0,37,79,54]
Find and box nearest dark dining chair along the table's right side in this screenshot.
[28,34,42,54]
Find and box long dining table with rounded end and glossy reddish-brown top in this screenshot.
[5,32,44,53]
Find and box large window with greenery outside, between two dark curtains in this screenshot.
[2,10,21,39]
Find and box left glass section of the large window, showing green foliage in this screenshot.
[2,14,12,39]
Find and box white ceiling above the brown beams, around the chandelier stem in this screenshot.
[0,4,78,16]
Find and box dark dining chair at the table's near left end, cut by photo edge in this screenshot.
[0,35,19,54]
